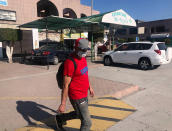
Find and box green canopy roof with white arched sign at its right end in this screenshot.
[19,9,136,31]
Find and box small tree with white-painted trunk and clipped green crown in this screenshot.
[0,28,20,63]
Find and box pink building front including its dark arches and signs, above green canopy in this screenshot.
[0,0,99,57]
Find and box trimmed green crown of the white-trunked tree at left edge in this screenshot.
[0,28,21,42]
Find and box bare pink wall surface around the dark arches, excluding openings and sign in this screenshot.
[0,0,99,25]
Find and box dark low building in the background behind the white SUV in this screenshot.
[116,19,172,44]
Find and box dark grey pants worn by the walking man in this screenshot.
[62,98,92,131]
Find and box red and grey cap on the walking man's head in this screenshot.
[75,38,89,50]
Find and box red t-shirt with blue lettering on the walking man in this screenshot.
[63,55,89,100]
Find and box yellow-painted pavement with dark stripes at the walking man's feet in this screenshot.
[16,97,136,131]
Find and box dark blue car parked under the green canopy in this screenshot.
[31,44,72,65]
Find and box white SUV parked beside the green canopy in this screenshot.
[103,42,167,70]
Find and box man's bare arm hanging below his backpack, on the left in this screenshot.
[57,76,71,113]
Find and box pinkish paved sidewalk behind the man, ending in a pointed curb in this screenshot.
[0,62,139,131]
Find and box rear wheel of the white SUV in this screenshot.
[139,58,151,70]
